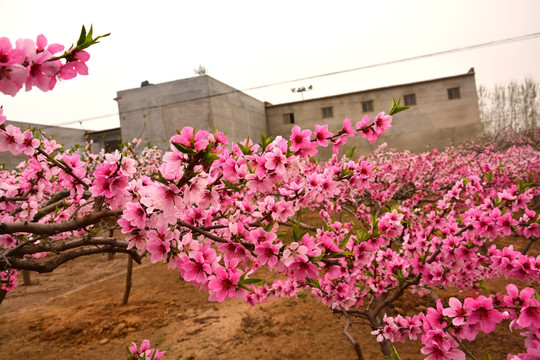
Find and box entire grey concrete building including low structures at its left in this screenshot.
[0,69,482,168]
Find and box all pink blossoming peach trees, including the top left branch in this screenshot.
[0,28,540,359]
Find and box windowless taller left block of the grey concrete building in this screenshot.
[116,75,266,149]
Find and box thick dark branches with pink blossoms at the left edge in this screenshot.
[0,129,159,272]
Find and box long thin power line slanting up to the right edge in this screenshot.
[38,32,540,126]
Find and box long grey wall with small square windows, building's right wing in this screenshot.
[266,69,482,158]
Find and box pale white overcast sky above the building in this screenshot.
[0,0,540,129]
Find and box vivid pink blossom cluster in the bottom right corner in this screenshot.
[373,284,540,360]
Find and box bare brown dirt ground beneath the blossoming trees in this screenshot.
[0,236,540,360]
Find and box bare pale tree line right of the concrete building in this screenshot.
[478,77,540,132]
